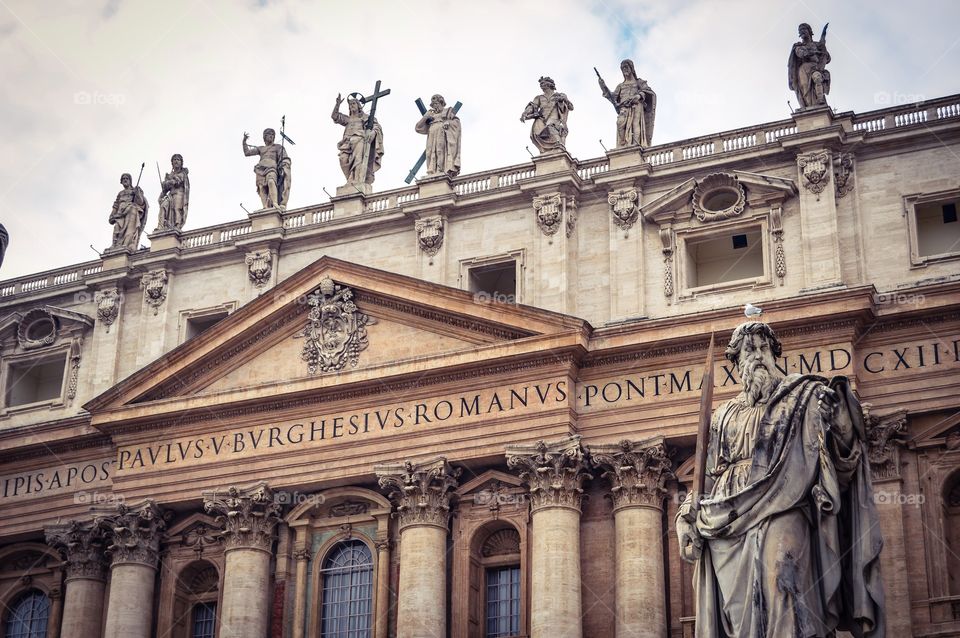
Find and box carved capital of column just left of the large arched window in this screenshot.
[203,481,280,553]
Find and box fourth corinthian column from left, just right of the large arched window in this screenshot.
[373,457,460,638]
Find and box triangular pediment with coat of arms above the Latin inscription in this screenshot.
[85,257,589,421]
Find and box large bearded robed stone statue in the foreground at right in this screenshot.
[676,322,885,638]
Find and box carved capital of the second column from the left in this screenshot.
[96,499,169,568]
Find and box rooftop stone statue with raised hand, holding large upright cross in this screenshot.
[330,93,383,186]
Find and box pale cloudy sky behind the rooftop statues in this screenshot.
[0,0,960,279]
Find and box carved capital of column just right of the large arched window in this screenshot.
[373,456,460,530]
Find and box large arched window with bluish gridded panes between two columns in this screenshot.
[320,540,373,638]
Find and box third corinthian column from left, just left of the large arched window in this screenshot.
[203,481,280,638]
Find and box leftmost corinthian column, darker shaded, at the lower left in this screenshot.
[45,520,107,638]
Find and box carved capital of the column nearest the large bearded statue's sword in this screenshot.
[589,437,673,511]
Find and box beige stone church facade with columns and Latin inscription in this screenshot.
[0,96,960,638]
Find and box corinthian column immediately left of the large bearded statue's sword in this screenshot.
[589,437,672,638]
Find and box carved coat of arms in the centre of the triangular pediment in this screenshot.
[294,277,376,374]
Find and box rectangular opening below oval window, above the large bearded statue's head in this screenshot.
[686,228,764,288]
